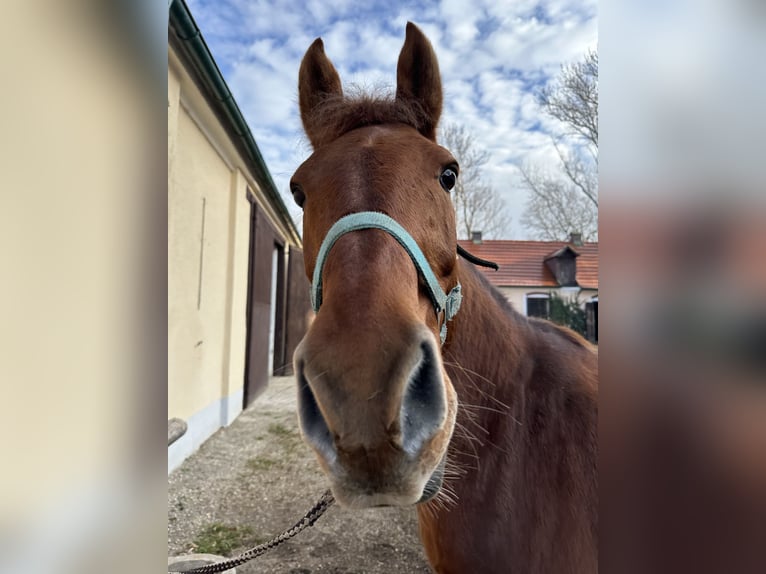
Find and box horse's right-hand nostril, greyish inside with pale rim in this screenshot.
[400,342,447,456]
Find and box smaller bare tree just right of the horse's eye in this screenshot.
[439,124,511,239]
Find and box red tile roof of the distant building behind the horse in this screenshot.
[458,239,598,289]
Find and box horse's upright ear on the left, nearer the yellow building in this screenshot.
[298,38,343,148]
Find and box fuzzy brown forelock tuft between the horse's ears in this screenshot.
[311,89,431,142]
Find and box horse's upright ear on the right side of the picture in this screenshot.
[396,22,442,141]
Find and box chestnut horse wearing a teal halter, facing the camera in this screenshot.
[290,23,598,574]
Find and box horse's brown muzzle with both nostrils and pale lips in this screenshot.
[295,331,456,507]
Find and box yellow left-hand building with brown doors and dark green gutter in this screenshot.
[168,0,310,471]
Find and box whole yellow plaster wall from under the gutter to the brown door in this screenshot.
[168,48,290,436]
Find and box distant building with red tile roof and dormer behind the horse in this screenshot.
[458,233,598,342]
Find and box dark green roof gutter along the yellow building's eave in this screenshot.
[169,0,302,246]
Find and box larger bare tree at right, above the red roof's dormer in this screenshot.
[521,48,598,240]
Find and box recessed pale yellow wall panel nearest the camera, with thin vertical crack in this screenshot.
[168,107,233,418]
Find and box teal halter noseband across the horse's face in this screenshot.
[311,211,463,345]
